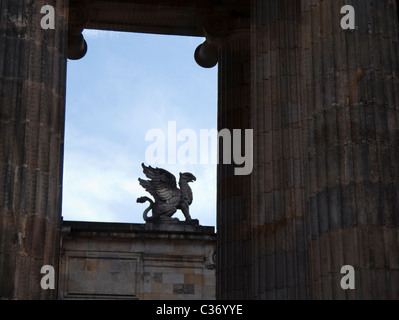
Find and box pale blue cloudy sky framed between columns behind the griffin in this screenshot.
[63,30,217,226]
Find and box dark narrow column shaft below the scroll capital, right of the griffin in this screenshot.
[216,28,251,299]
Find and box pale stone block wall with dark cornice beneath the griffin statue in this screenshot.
[58,221,216,300]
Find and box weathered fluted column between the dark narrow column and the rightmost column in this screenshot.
[251,0,309,299]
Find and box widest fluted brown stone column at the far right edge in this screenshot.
[302,0,399,299]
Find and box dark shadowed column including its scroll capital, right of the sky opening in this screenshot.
[195,11,251,299]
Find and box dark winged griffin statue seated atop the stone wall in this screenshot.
[137,163,198,222]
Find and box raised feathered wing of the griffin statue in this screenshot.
[139,164,180,204]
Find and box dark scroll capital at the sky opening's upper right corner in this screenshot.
[194,11,250,68]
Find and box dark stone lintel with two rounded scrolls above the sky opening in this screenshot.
[68,0,250,63]
